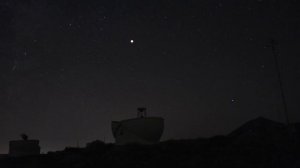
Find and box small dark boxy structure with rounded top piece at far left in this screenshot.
[9,134,41,157]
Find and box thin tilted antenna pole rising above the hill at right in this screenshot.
[271,39,290,125]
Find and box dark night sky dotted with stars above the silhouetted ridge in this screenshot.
[0,0,300,153]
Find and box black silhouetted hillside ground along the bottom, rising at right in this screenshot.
[0,118,300,168]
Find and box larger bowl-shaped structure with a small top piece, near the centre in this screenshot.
[111,108,164,145]
